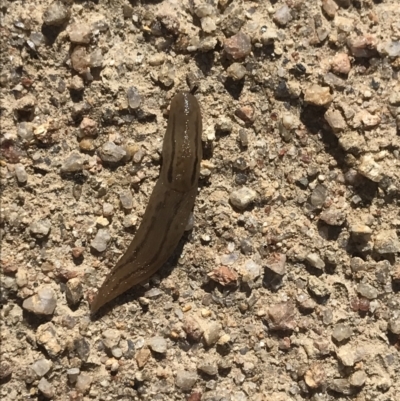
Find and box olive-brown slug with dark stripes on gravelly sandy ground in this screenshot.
[90,92,202,314]
